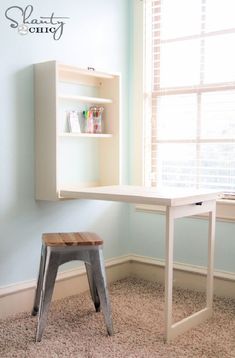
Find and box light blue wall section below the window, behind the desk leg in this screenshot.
[129,206,235,273]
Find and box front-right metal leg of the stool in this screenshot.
[90,248,113,336]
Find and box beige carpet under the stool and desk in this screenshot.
[0,279,235,358]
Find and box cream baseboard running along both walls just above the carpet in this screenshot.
[0,255,235,318]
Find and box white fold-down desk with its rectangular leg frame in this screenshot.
[60,185,221,342]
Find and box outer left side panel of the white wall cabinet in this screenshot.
[34,61,57,200]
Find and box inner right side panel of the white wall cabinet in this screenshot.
[100,76,121,185]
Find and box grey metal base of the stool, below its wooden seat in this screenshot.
[32,244,113,342]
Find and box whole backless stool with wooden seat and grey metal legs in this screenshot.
[32,232,113,342]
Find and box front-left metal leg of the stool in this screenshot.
[36,247,59,342]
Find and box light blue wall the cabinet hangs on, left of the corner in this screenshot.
[0,0,129,285]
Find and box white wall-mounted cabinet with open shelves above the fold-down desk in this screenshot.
[34,61,120,200]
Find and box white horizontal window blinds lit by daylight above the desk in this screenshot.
[144,0,235,193]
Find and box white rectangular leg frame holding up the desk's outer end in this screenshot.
[164,201,216,342]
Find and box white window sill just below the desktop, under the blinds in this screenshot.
[135,199,235,222]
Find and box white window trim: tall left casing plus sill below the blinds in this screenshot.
[130,0,235,222]
